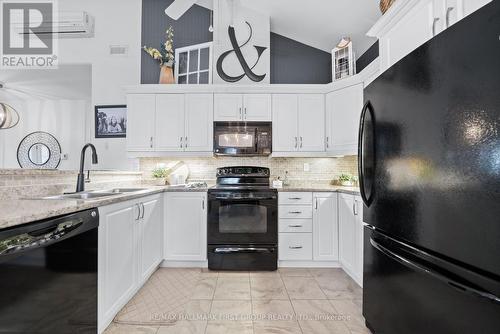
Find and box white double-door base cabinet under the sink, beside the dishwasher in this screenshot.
[98,195,163,333]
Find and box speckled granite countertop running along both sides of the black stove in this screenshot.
[0,185,359,229]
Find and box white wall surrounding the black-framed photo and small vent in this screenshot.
[59,0,142,169]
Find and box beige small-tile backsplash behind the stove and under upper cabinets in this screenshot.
[140,156,358,184]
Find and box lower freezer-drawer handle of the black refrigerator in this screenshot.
[370,238,500,304]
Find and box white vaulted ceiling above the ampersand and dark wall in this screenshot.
[198,0,382,56]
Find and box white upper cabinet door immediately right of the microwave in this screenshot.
[272,94,299,152]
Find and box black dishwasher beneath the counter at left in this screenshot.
[0,209,99,334]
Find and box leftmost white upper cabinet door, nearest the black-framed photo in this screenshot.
[127,94,156,151]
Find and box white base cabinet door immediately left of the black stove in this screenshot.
[165,192,207,261]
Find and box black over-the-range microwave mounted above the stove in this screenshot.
[214,122,273,156]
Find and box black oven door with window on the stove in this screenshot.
[208,191,278,245]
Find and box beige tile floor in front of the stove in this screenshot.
[105,268,370,334]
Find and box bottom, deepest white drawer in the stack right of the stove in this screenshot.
[278,233,312,261]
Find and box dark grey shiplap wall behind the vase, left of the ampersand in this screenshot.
[141,0,213,84]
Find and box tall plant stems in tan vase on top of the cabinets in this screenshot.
[142,26,175,84]
